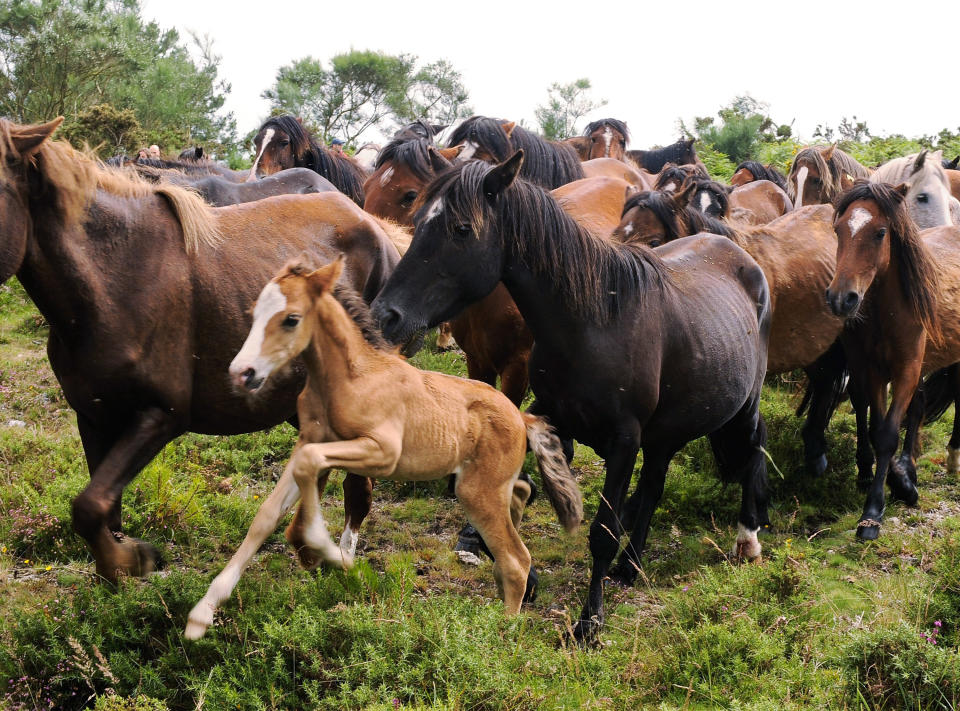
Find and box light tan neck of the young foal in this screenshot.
[303,295,377,398]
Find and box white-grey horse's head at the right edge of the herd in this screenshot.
[870,151,960,229]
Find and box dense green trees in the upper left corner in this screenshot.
[0,0,236,153]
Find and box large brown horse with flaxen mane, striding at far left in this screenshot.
[0,119,399,582]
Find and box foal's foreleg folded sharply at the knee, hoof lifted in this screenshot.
[291,437,399,568]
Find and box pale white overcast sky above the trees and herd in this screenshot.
[143,0,960,148]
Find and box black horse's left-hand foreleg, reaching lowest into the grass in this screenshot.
[573,440,640,643]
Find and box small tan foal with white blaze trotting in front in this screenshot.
[184,258,583,639]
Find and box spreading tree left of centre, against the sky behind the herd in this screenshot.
[262,50,469,144]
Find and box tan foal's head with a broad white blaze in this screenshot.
[230,255,343,393]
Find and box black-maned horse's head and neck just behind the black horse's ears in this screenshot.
[447,116,585,190]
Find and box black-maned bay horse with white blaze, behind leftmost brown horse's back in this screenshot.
[247,114,367,206]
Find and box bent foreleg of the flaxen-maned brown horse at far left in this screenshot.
[73,408,180,583]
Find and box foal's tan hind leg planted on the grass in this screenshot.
[457,464,532,615]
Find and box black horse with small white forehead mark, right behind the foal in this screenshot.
[372,151,770,641]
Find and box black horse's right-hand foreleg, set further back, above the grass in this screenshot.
[610,446,679,587]
